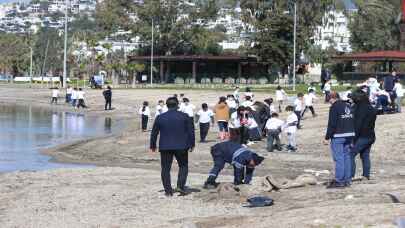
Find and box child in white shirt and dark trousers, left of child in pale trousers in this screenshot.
[265,112,284,152]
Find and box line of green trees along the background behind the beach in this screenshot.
[0,0,400,80]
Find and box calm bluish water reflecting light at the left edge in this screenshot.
[0,105,123,172]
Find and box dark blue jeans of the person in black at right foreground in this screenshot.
[352,138,375,178]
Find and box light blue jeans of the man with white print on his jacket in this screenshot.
[331,138,352,184]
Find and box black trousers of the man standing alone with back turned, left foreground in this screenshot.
[160,149,188,193]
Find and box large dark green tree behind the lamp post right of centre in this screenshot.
[241,0,334,67]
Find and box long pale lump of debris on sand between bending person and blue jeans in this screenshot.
[265,174,318,191]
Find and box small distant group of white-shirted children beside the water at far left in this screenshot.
[51,86,87,109]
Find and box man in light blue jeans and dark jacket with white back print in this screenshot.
[324,92,355,188]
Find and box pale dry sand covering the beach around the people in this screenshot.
[0,86,405,228]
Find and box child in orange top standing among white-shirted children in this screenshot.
[214,97,230,141]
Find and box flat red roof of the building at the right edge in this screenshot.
[333,51,405,62]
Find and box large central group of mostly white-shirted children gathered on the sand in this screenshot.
[139,87,318,152]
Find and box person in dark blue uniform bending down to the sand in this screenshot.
[204,141,264,188]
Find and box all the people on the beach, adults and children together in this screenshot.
[45,72,404,196]
